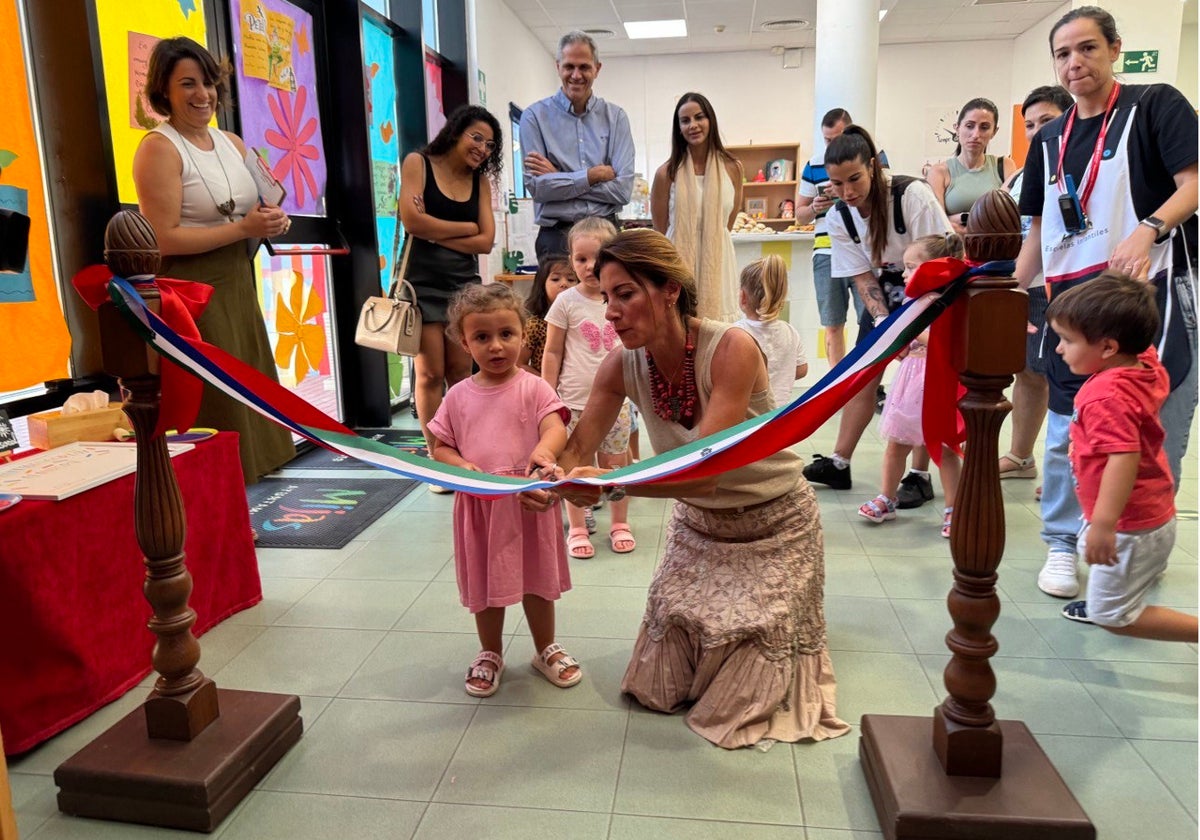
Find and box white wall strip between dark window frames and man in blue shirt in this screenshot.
[472,0,559,198]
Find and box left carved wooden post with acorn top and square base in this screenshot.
[54,210,302,832]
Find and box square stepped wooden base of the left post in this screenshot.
[54,689,304,832]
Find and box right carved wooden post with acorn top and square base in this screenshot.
[859,190,1096,840]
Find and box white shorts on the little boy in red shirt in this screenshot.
[1078,518,1175,628]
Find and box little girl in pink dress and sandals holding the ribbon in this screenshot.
[428,283,583,697]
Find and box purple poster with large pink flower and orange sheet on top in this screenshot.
[230,0,325,216]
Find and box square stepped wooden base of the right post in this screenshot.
[858,714,1096,840]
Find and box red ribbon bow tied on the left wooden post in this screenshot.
[71,265,212,437]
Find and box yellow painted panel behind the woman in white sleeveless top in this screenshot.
[96,0,208,204]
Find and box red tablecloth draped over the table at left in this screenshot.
[0,432,263,755]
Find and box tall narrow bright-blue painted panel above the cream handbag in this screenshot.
[362,16,403,289]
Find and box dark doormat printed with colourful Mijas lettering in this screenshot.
[246,478,418,548]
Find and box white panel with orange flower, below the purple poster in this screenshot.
[254,250,343,420]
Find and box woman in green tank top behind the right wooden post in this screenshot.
[929,97,1016,235]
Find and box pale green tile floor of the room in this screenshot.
[10,403,1198,840]
